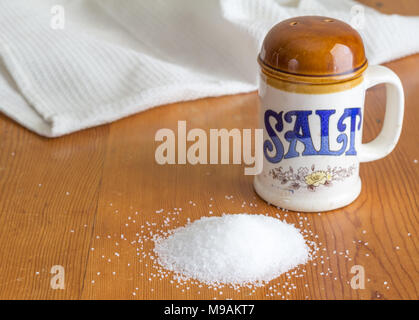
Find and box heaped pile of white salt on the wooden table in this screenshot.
[154,214,310,285]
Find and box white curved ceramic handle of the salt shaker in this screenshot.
[358,66,404,162]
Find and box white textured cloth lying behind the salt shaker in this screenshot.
[0,0,419,137]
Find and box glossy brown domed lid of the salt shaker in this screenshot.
[258,16,367,83]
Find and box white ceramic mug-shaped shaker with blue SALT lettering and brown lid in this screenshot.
[254,16,404,212]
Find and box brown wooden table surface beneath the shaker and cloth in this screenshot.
[0,1,419,299]
